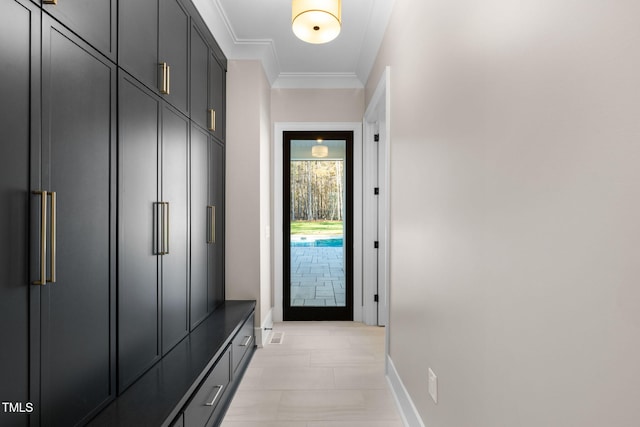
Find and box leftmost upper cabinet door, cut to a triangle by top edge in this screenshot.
[43,0,116,61]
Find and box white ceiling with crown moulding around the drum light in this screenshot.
[193,0,393,88]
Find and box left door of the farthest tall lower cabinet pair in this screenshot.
[190,125,213,329]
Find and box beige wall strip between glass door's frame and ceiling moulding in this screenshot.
[271,89,364,123]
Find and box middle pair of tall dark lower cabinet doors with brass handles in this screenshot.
[118,72,189,391]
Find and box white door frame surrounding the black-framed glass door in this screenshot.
[271,122,363,322]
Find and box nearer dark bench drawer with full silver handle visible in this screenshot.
[184,349,231,427]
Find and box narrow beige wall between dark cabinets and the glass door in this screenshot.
[226,61,272,326]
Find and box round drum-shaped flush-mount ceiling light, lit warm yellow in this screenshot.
[291,0,342,44]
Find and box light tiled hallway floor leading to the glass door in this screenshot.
[222,322,402,427]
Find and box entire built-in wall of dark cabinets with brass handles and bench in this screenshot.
[0,0,236,427]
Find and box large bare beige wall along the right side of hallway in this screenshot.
[367,0,640,427]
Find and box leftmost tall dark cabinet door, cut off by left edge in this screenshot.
[0,0,40,426]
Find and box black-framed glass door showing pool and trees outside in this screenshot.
[283,131,353,320]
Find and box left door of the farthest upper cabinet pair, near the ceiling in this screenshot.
[191,25,210,129]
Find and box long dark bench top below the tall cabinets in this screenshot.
[88,301,255,427]
